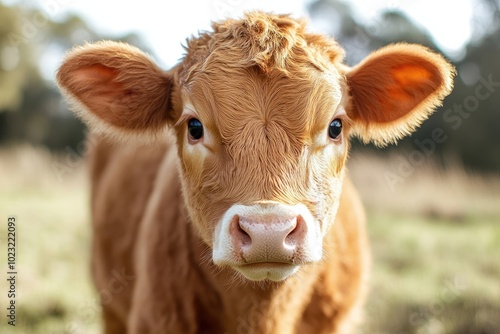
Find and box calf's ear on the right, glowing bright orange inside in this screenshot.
[346,44,455,146]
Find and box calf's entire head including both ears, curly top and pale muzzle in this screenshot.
[57,12,454,281]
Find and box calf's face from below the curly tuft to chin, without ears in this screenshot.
[179,64,349,280]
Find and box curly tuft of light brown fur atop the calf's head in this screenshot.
[181,12,344,81]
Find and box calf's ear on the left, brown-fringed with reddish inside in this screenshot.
[56,41,173,134]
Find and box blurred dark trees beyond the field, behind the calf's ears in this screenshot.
[0,0,500,173]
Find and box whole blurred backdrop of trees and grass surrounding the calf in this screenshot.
[0,0,500,334]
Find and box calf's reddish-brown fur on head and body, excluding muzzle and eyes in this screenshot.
[57,12,453,334]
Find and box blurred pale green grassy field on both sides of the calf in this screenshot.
[0,147,500,334]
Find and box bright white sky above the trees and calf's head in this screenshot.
[3,0,477,74]
